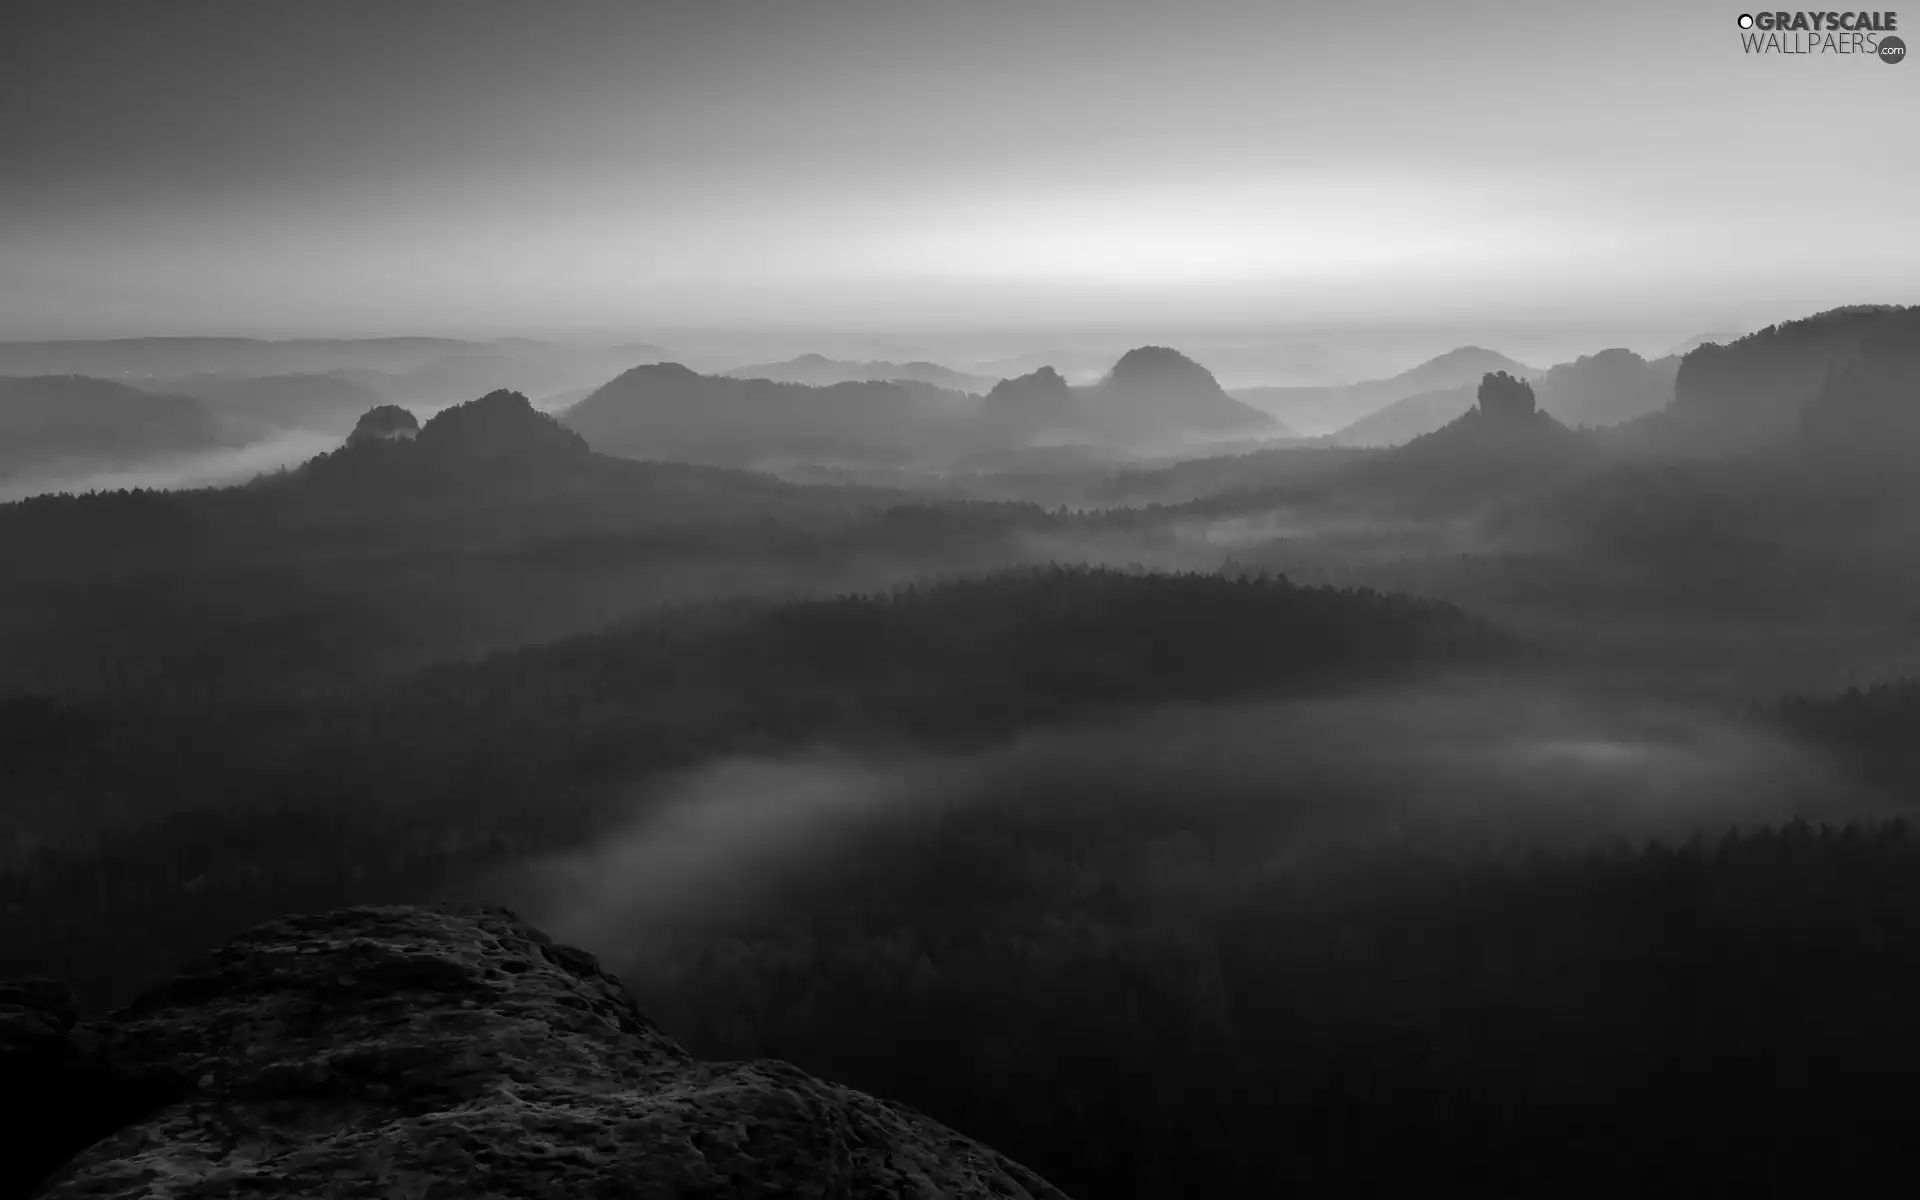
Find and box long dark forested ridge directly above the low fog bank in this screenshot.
[0,568,1511,1002]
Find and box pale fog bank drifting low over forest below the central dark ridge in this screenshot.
[492,676,1880,979]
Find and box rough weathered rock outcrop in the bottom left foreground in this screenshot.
[0,908,1062,1198]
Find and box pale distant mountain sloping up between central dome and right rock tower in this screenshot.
[1233,346,1538,437]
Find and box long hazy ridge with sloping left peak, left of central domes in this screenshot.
[563,363,968,463]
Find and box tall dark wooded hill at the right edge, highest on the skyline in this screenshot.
[1644,305,1908,453]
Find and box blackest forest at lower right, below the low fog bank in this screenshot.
[637,799,1920,1198]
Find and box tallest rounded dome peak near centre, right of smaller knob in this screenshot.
[1079,346,1281,444]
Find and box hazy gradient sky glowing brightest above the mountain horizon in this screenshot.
[0,0,1920,338]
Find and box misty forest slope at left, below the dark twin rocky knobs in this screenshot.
[0,472,1067,699]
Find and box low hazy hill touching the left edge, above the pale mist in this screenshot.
[0,374,234,476]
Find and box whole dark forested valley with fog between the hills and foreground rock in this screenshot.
[11,309,1920,1198]
